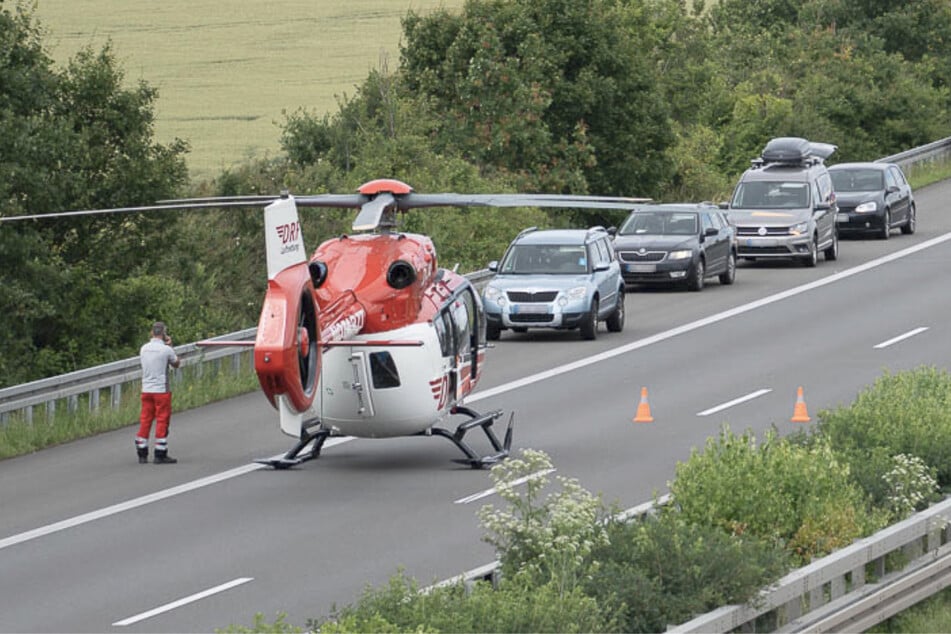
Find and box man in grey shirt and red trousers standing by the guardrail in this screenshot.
[135,321,181,464]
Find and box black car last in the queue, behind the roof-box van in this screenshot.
[829,163,917,240]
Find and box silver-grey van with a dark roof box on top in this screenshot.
[729,137,839,266]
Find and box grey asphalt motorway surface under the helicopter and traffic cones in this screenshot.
[0,182,951,632]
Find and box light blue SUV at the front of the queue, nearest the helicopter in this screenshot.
[482,227,624,340]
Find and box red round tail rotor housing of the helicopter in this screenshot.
[254,264,321,413]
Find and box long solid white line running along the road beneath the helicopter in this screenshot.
[0,233,951,550]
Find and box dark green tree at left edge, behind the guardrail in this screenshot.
[0,3,187,384]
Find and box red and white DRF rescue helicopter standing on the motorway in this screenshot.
[0,179,648,469]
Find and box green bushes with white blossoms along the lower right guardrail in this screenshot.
[224,367,951,633]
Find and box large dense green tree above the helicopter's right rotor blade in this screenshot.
[401,0,673,195]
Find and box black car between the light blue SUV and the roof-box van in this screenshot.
[614,203,736,291]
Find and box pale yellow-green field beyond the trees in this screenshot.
[36,0,463,179]
